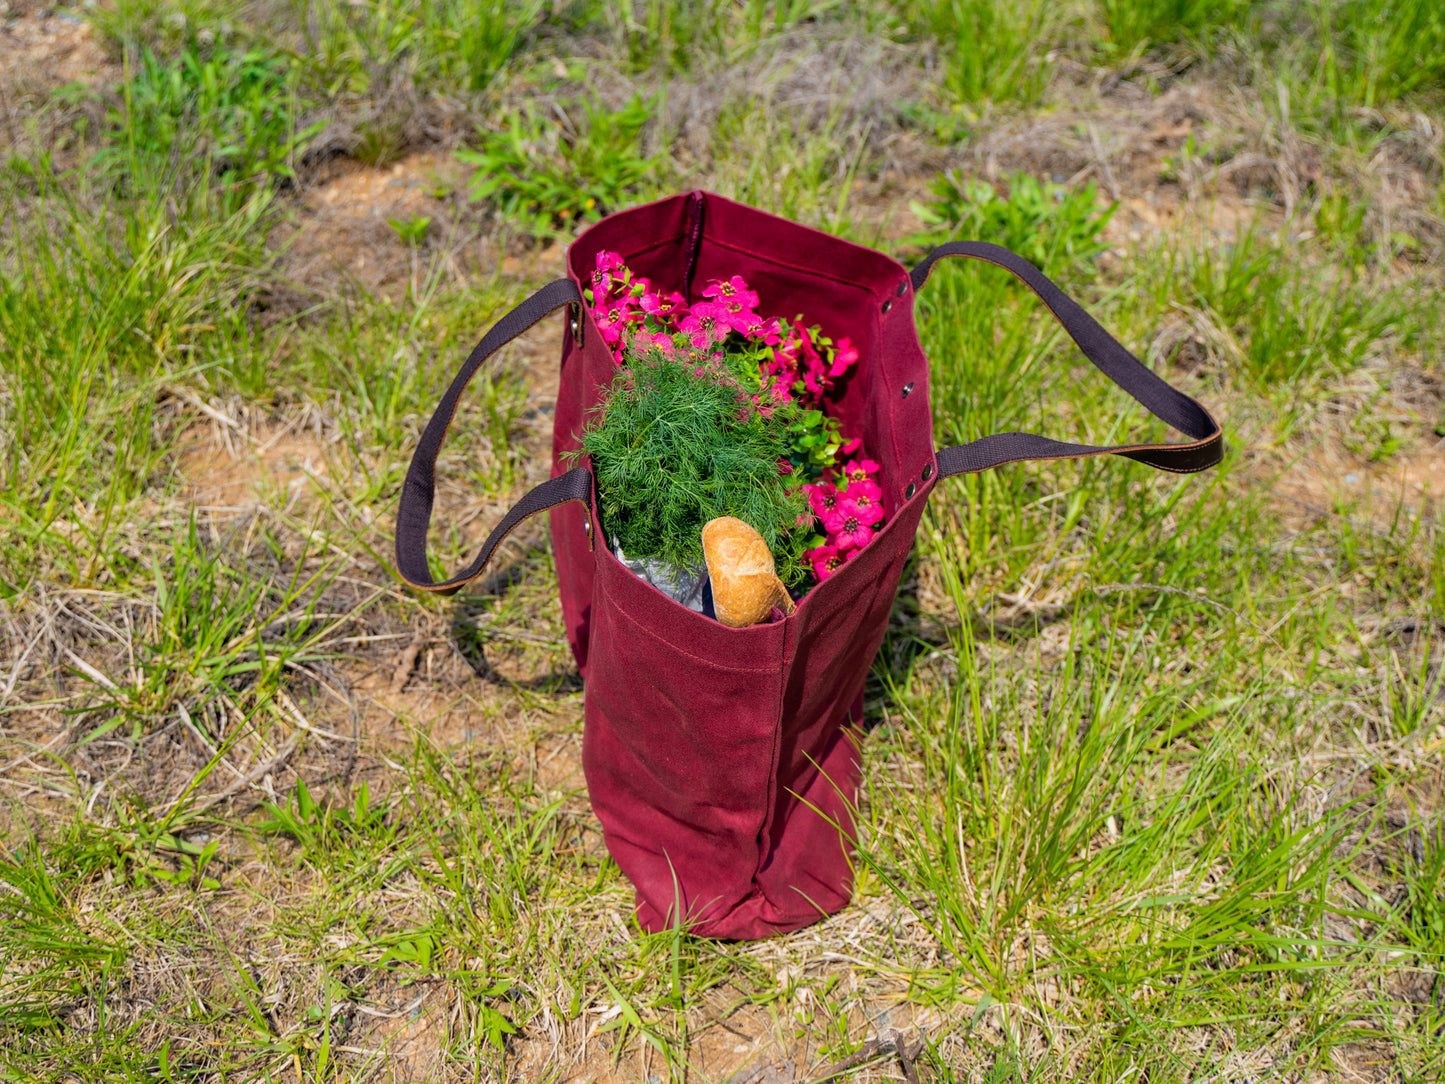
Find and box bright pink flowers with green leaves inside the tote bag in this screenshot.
[588,251,883,580]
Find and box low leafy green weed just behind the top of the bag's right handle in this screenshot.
[912,173,1116,275]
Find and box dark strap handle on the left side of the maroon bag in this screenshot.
[396,271,592,594]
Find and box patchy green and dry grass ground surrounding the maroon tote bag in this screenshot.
[0,0,1445,1084]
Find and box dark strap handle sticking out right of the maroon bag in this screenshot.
[909,241,1224,478]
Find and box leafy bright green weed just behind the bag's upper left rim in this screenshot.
[457,94,666,237]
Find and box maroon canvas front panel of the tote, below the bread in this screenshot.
[582,546,786,921]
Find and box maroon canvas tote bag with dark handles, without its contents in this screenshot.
[396,192,1222,938]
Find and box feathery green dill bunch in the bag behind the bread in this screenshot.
[582,351,811,584]
